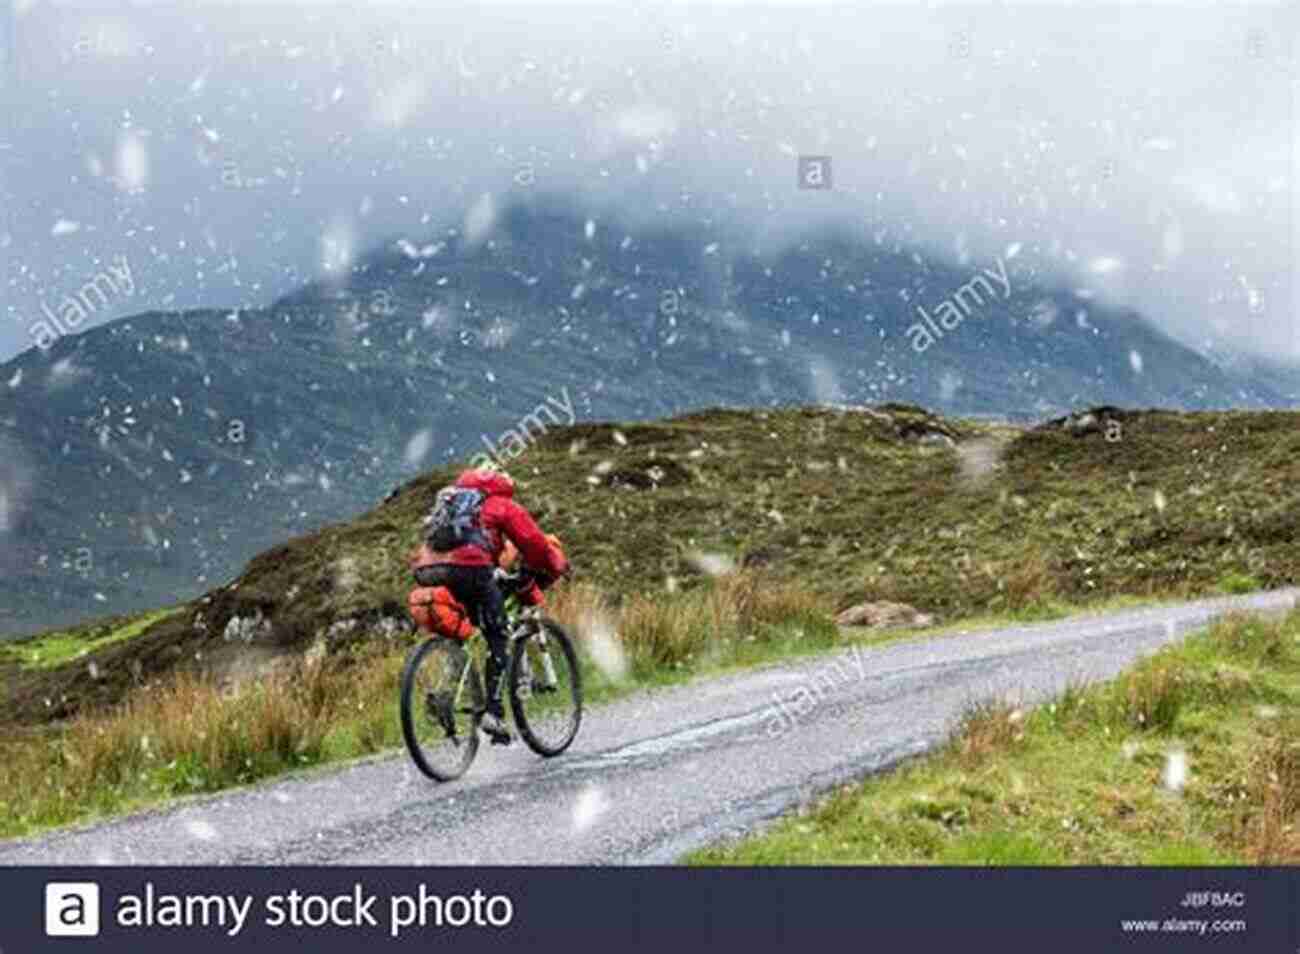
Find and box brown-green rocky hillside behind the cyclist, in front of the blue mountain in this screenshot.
[0,404,1300,721]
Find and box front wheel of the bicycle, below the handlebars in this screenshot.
[510,619,582,756]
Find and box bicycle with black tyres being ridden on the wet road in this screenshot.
[400,571,582,781]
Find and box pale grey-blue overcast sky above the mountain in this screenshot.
[0,0,1300,360]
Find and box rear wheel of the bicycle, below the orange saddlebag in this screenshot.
[400,637,484,781]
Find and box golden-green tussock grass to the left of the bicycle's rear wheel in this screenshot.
[0,646,403,836]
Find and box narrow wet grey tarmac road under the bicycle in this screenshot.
[0,589,1300,864]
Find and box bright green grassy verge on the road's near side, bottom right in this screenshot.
[689,612,1300,864]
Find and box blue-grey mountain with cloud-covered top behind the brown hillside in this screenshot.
[0,196,1296,636]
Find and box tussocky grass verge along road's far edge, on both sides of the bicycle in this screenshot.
[0,573,841,837]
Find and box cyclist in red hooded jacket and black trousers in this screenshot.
[411,465,569,742]
